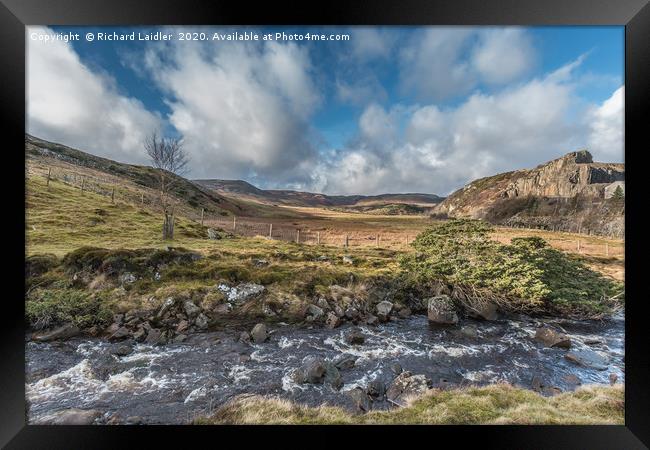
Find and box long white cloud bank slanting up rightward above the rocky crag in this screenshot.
[319,56,623,195]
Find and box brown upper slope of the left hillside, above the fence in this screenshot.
[25,134,304,217]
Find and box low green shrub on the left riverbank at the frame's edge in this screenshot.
[25,288,112,328]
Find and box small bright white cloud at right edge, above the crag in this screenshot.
[587,86,625,161]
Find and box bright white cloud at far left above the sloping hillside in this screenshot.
[26,27,161,163]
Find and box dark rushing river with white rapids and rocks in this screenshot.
[26,313,625,424]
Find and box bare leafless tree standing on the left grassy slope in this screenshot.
[144,131,189,239]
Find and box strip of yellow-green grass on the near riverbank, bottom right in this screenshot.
[194,384,625,425]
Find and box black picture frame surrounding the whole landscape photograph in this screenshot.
[0,0,650,449]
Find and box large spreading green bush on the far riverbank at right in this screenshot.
[400,219,622,315]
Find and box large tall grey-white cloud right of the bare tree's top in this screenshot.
[145,35,321,187]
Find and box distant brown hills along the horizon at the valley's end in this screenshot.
[194,180,443,207]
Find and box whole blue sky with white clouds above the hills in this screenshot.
[26,26,624,195]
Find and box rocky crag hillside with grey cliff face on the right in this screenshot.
[434,150,625,237]
